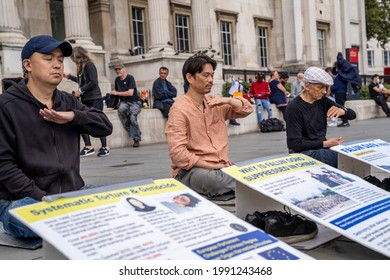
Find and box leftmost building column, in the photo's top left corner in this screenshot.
[0,0,26,44]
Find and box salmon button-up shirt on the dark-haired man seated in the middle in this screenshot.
[165,95,253,178]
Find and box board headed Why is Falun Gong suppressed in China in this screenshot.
[223,153,390,256]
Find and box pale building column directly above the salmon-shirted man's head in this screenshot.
[191,0,211,52]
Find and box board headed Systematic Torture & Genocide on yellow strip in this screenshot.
[12,179,312,260]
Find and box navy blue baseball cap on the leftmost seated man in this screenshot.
[21,35,73,61]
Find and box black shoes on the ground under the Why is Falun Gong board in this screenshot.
[245,207,318,244]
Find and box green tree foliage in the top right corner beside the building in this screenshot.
[365,0,390,48]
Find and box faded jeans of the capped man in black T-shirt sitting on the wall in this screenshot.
[118,102,141,141]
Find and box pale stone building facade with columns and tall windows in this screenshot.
[0,0,369,94]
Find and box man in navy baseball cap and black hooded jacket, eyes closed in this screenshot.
[0,35,112,238]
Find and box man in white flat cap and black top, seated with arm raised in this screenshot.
[285,67,356,168]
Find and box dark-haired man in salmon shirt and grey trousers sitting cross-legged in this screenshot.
[165,54,253,198]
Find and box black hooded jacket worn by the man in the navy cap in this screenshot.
[0,80,112,200]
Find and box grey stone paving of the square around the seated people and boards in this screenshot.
[0,118,390,260]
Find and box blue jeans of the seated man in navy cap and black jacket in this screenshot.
[0,197,39,238]
